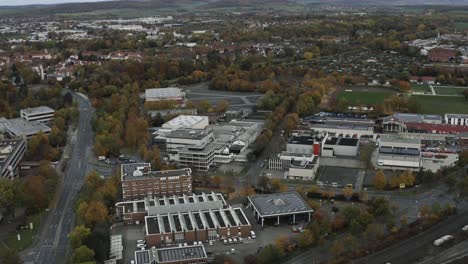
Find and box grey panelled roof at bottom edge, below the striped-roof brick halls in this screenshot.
[156,245,207,263]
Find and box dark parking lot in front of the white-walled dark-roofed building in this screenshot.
[317,167,364,188]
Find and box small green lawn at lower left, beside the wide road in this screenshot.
[5,211,45,251]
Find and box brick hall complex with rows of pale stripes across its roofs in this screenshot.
[116,193,251,247]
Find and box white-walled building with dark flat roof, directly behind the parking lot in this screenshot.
[322,135,359,157]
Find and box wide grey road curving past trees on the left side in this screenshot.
[20,93,94,264]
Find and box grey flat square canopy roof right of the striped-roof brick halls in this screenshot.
[249,192,313,217]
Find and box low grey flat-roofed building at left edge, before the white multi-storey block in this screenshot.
[0,118,50,139]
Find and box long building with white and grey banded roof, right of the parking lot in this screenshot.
[377,135,421,170]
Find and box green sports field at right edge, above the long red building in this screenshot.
[412,95,468,114]
